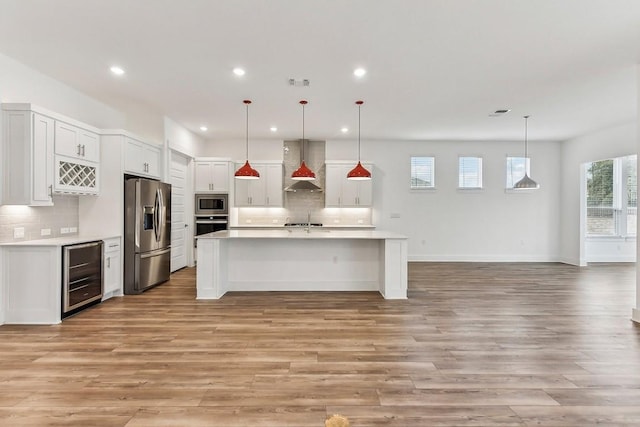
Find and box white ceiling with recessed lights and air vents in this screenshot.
[0,0,640,144]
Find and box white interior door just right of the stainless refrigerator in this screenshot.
[169,152,189,272]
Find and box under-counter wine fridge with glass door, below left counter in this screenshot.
[61,240,103,318]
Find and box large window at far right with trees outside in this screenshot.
[586,155,638,237]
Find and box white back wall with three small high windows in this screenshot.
[327,141,560,261]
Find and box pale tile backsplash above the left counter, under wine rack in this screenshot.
[0,195,79,243]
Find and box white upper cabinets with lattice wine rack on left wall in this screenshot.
[2,104,100,206]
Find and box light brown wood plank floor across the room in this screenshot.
[0,263,640,427]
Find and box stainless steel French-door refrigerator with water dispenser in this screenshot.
[124,178,171,295]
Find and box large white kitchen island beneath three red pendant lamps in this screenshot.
[196,231,407,299]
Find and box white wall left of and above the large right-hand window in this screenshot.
[560,123,638,265]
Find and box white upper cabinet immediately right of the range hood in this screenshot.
[325,162,373,208]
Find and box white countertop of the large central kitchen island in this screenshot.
[196,231,407,240]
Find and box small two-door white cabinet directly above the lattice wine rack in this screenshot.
[55,121,100,163]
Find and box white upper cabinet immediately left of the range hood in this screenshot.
[234,163,283,207]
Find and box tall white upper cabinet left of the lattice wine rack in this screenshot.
[2,105,55,206]
